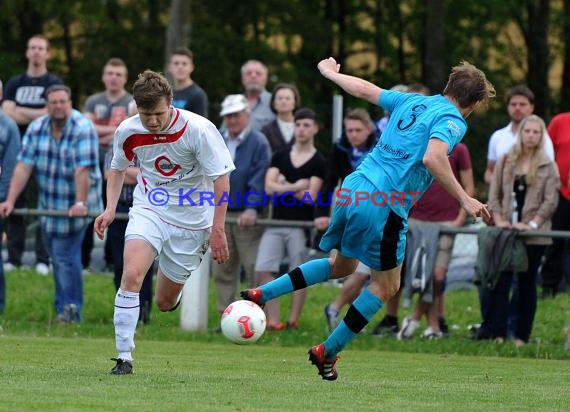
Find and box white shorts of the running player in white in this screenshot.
[125,207,210,284]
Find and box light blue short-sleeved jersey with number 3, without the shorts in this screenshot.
[356,90,467,218]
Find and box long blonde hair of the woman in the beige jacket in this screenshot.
[504,114,546,186]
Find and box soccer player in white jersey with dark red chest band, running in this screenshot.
[95,70,235,375]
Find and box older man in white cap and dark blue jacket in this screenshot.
[213,94,271,313]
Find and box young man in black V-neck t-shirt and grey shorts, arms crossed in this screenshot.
[255,108,326,330]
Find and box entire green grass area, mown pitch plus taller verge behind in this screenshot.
[0,271,570,411]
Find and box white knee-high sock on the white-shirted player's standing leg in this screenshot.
[113,289,140,361]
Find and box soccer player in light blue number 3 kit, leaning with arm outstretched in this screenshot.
[242,57,495,380]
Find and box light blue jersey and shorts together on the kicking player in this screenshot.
[320,90,467,271]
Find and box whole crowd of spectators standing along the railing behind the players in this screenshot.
[0,35,570,352]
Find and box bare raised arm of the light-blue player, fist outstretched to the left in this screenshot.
[317,57,383,105]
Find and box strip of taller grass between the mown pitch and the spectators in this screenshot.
[0,270,570,359]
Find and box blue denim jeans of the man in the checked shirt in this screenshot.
[42,226,87,320]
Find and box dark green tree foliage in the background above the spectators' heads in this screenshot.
[0,0,567,181]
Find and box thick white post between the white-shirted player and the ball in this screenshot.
[180,250,211,331]
